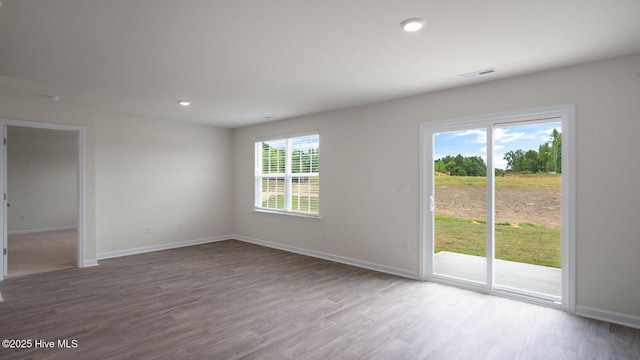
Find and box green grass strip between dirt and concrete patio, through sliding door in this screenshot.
[434,215,562,268]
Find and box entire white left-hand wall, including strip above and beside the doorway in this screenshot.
[0,88,233,265]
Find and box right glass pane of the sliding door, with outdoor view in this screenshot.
[494,122,562,298]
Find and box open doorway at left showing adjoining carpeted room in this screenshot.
[0,120,84,280]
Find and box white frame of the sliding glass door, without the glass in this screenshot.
[419,104,576,313]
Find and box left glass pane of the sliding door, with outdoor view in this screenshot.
[433,128,487,283]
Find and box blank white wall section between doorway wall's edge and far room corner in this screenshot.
[96,113,233,256]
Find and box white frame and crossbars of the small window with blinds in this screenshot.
[254,131,321,219]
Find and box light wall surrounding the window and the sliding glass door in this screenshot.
[234,54,640,318]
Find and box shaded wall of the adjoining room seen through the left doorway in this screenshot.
[6,126,78,233]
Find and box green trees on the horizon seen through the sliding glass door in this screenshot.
[434,129,562,176]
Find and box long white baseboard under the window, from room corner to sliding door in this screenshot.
[229,235,419,280]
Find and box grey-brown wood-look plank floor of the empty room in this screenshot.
[0,241,640,360]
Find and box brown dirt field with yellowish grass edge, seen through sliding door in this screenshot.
[435,175,562,228]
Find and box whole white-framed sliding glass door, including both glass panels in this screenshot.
[422,105,572,306]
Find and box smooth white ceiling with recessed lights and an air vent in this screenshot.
[0,0,640,128]
